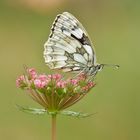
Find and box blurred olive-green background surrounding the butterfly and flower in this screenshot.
[0,0,140,140]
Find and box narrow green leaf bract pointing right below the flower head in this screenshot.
[59,110,95,118]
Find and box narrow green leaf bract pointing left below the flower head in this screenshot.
[17,105,48,115]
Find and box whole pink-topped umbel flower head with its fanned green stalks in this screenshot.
[16,68,95,111]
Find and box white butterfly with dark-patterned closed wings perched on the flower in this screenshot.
[44,12,118,76]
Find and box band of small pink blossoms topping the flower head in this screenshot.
[16,68,94,91]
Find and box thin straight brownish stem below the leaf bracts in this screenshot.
[52,114,56,140]
